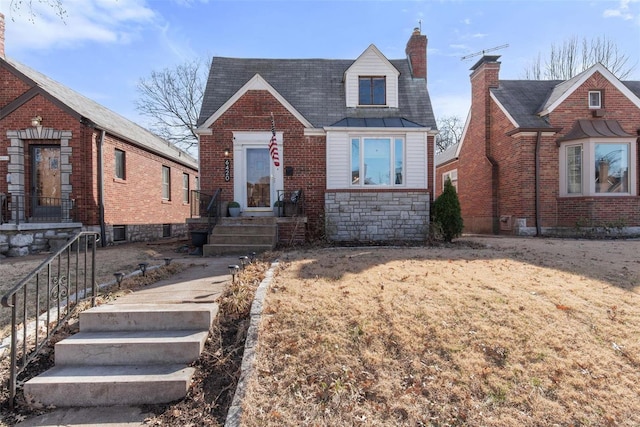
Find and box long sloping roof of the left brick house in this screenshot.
[6,58,198,169]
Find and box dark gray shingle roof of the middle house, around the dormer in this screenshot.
[198,57,436,129]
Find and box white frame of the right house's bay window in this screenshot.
[558,138,638,197]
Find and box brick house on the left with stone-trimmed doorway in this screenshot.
[0,17,198,256]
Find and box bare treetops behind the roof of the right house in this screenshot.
[524,36,635,80]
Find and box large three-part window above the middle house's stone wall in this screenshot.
[351,137,405,187]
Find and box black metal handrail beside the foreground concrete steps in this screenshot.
[2,231,100,406]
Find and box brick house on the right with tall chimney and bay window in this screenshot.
[436,56,640,235]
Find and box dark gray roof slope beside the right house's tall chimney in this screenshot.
[491,80,562,128]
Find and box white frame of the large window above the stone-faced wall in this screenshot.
[349,134,407,188]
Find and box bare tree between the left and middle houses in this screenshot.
[136,58,208,150]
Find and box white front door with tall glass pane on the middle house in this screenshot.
[233,132,283,215]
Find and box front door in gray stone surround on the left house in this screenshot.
[31,145,62,218]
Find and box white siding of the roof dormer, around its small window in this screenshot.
[345,47,399,108]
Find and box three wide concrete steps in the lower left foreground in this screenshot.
[24,304,218,407]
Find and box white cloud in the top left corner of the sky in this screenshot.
[3,0,156,51]
